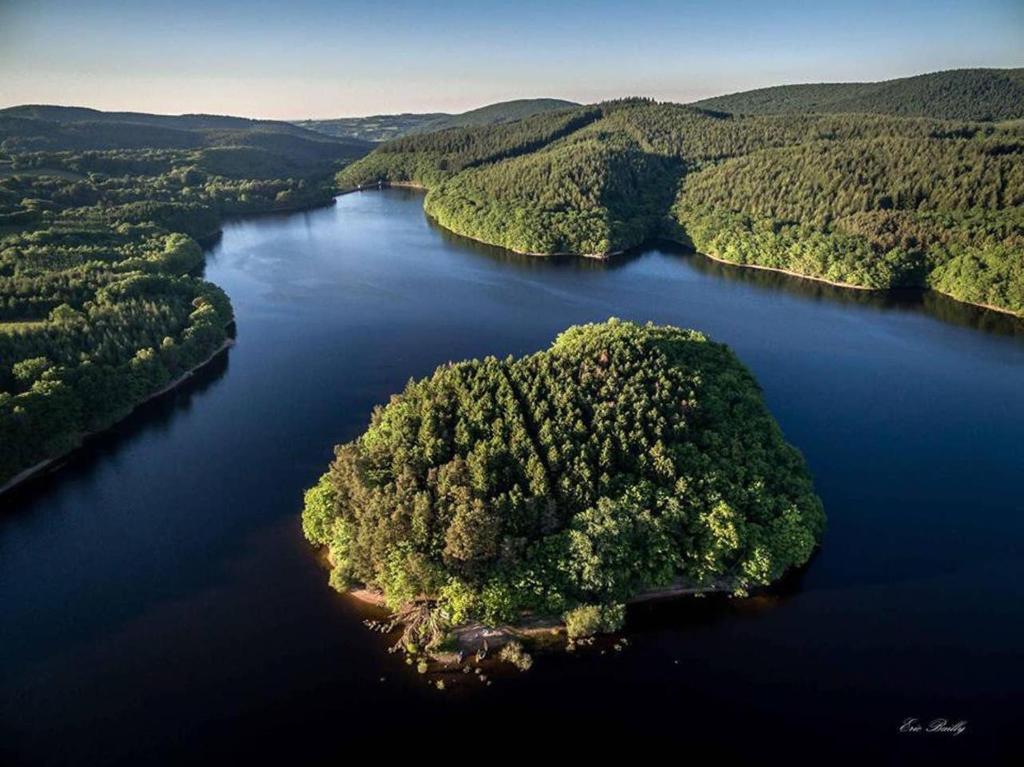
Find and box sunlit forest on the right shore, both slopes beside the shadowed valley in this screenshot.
[338,73,1024,313]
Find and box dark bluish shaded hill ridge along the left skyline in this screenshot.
[0,105,373,177]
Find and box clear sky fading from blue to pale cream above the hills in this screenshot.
[0,0,1024,120]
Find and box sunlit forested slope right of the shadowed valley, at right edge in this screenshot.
[674,129,1024,312]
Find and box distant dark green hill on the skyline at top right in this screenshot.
[693,69,1024,121]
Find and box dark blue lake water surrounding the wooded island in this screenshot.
[0,190,1024,765]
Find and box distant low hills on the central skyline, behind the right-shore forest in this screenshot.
[296,98,579,141]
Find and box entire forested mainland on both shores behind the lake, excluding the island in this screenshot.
[0,71,1024,483]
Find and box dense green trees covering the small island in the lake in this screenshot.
[302,319,824,633]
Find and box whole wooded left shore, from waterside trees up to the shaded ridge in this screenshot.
[0,108,366,485]
